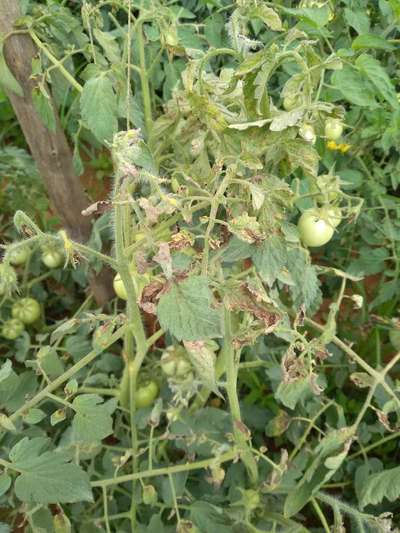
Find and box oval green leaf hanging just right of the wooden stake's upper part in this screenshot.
[80,75,118,142]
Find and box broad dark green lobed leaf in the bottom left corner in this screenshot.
[10,437,93,504]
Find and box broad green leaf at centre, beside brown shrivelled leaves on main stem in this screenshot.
[157,276,222,341]
